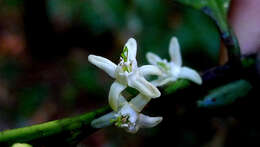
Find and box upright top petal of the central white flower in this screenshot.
[125,38,137,61]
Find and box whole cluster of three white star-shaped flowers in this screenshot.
[88,37,201,133]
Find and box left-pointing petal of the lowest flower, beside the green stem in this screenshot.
[91,112,116,128]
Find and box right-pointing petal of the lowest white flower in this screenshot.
[138,114,163,128]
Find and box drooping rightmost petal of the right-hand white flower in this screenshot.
[178,67,202,85]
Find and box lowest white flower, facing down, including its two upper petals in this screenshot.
[91,86,162,133]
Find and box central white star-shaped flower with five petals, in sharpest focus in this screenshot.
[88,38,162,112]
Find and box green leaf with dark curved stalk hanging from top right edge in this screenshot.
[176,0,240,63]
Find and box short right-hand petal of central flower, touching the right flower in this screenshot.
[139,65,162,76]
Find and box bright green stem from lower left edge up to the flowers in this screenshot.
[0,106,109,146]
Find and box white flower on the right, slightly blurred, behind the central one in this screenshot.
[146,37,202,86]
